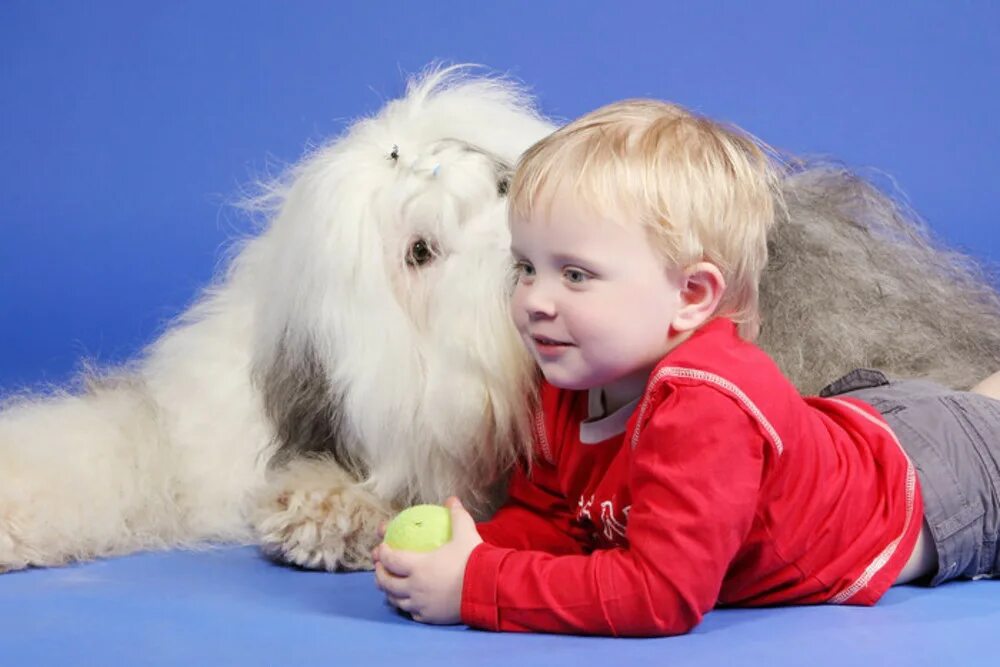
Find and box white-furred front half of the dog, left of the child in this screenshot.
[0,70,552,569]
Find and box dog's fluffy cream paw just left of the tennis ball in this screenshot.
[254,460,391,571]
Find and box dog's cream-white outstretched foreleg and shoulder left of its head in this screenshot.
[0,280,273,570]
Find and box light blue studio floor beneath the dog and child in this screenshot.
[0,548,1000,667]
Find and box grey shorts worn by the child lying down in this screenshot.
[820,369,1000,586]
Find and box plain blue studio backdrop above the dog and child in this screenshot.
[0,0,1000,390]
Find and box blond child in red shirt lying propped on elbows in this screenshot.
[375,100,1000,636]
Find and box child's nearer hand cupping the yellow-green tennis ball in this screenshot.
[375,498,483,625]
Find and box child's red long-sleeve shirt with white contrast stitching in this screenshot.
[461,320,923,635]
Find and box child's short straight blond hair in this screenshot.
[510,100,780,340]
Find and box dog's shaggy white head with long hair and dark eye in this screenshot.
[251,68,552,503]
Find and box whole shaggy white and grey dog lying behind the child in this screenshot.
[0,68,1000,570]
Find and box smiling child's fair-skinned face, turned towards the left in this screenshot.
[511,192,684,404]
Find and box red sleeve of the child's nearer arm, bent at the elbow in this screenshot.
[462,385,768,636]
